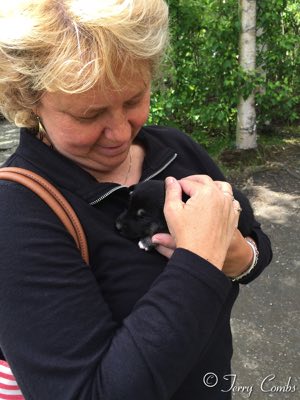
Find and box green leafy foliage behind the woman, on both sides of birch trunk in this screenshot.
[149,0,300,145]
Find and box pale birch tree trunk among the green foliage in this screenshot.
[236,0,257,149]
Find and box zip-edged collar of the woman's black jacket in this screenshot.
[15,127,176,204]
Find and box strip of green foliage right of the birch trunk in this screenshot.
[257,0,300,123]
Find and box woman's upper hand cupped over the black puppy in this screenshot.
[153,175,239,269]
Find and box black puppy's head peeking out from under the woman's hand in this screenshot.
[116,180,167,239]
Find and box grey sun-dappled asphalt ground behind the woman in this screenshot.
[0,122,300,400]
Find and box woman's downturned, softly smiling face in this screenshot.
[34,79,150,176]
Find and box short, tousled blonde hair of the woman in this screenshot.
[0,0,168,127]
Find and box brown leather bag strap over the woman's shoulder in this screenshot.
[0,167,89,264]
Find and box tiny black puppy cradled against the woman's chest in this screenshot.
[116,180,254,251]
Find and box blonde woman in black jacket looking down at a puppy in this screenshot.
[0,0,271,400]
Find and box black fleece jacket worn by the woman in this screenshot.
[0,127,272,400]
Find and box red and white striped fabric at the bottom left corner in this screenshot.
[0,360,25,400]
